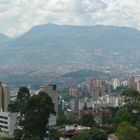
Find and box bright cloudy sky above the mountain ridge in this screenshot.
[0,0,140,37]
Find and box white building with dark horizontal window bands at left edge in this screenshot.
[0,112,17,136]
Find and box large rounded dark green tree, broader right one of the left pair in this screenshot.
[21,92,55,140]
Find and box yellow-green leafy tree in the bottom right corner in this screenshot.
[115,122,140,140]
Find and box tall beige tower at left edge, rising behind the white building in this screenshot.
[0,82,10,112]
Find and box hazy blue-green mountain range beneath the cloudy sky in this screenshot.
[0,24,140,70]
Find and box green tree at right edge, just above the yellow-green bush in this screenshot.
[115,88,140,125]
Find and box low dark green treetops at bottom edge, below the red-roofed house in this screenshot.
[71,128,107,140]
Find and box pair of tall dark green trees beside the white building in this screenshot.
[9,87,55,140]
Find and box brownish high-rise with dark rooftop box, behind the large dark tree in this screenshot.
[40,84,58,115]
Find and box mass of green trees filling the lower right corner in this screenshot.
[71,89,140,140]
